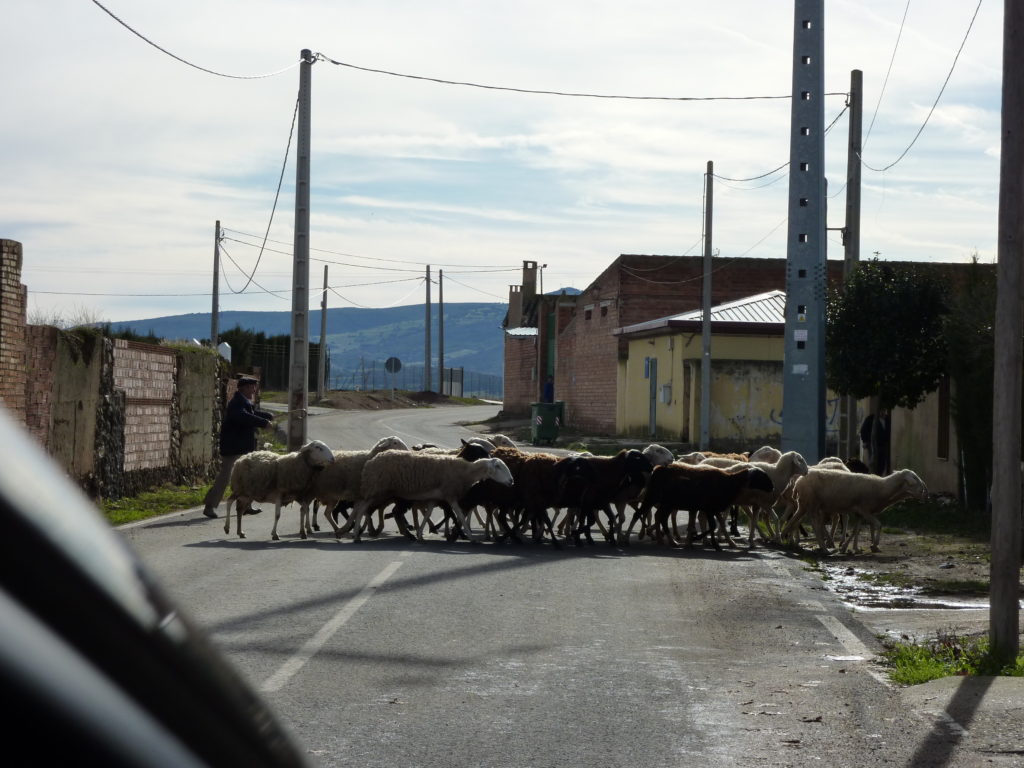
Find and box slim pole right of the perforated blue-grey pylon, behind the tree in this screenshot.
[839,70,864,459]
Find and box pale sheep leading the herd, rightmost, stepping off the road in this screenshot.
[783,467,928,553]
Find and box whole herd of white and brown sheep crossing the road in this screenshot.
[218,435,928,553]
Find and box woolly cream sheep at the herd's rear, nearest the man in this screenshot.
[224,440,334,541]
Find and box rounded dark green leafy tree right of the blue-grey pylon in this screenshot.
[825,259,949,473]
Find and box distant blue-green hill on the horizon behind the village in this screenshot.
[111,302,508,378]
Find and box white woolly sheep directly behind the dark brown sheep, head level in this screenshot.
[346,451,512,542]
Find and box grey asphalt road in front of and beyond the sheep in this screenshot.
[122,407,1007,768]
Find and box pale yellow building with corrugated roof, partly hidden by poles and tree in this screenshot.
[613,291,959,495]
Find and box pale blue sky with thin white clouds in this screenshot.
[0,0,1002,323]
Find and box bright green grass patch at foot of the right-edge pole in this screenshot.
[882,632,1024,685]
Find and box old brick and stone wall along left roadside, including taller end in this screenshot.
[0,240,228,505]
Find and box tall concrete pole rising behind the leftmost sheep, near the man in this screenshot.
[288,49,313,451]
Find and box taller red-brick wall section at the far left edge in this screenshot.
[0,240,28,421]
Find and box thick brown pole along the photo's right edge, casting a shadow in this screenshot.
[988,0,1024,663]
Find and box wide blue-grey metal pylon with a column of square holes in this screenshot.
[782,0,827,464]
